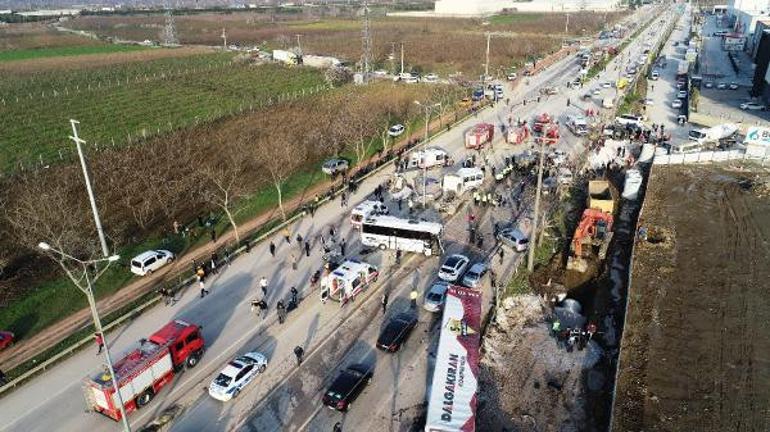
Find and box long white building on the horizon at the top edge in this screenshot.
[435,0,620,16]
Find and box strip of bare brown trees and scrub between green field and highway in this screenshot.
[0,83,459,302]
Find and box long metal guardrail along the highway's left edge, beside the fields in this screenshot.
[0,98,491,397]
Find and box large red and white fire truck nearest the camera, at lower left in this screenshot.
[83,319,205,421]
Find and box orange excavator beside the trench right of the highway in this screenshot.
[567,208,613,273]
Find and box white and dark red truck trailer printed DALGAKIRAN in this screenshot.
[425,285,481,432]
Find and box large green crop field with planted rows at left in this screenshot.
[0,54,324,172]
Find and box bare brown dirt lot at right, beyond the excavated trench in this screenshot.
[611,165,770,431]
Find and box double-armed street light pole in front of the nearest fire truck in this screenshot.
[37,241,131,432]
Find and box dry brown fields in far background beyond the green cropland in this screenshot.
[67,13,623,78]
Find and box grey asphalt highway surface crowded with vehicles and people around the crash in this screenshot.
[0,4,664,432]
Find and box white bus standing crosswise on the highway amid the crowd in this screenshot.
[361,216,444,256]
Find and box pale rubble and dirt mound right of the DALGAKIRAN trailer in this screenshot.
[477,295,606,431]
